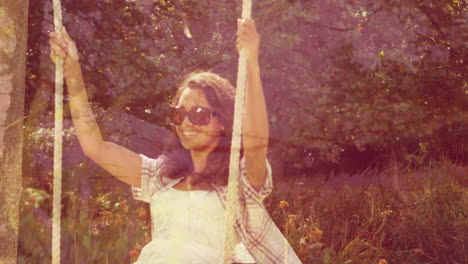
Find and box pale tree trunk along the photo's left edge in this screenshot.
[0,0,29,263]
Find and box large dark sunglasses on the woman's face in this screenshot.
[171,106,216,126]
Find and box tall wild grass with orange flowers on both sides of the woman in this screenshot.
[18,159,468,264]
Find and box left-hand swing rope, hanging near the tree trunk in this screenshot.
[52,0,63,264]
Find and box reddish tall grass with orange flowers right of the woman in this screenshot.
[267,160,468,264]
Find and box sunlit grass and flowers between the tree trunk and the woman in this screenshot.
[18,184,151,263]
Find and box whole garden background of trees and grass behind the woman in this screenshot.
[0,0,468,264]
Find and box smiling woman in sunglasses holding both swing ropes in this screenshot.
[50,17,300,264]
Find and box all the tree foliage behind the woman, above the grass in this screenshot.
[26,0,468,173]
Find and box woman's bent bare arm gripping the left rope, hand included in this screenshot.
[50,28,141,187]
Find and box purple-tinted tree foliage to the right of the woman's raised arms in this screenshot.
[259,1,466,167]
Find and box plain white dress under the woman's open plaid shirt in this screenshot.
[135,157,255,264]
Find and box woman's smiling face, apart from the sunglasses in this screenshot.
[175,87,223,152]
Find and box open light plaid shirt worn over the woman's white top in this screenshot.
[132,155,301,264]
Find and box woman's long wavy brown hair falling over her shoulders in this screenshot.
[160,71,235,190]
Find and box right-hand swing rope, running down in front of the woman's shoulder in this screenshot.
[224,0,252,264]
